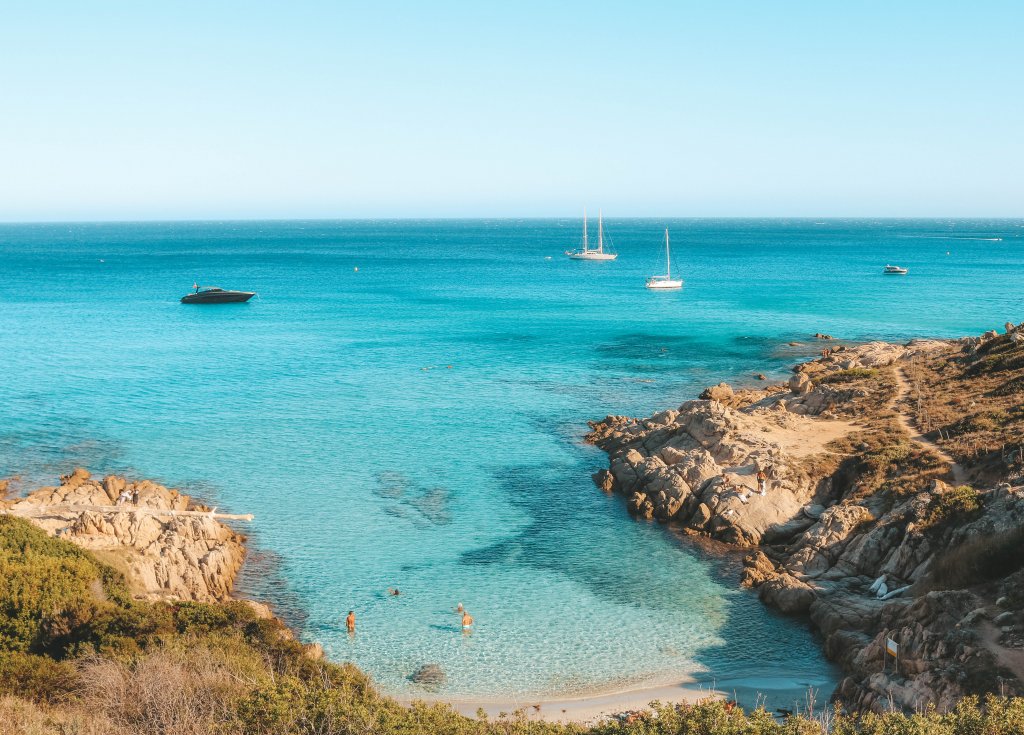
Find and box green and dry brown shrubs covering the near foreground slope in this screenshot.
[0,507,1024,735]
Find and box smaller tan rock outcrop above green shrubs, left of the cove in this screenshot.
[5,468,245,601]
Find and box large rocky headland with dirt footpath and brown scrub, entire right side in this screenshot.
[588,323,1024,710]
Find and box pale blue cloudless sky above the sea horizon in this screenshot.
[0,0,1024,221]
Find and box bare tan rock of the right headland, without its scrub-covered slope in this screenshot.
[588,333,1024,710]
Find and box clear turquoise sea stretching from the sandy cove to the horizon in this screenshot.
[0,220,1024,698]
